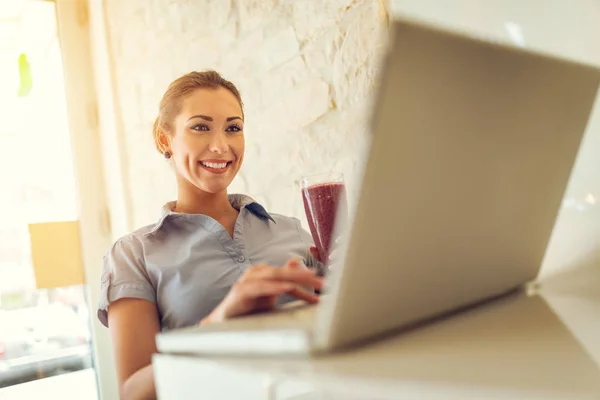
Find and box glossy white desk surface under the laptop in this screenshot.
[154,266,600,400]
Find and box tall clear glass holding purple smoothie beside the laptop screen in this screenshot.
[299,172,347,264]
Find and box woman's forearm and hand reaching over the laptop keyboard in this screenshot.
[200,260,323,325]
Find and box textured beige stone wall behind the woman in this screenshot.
[104,0,387,228]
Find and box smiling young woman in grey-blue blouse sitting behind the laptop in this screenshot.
[98,71,322,399]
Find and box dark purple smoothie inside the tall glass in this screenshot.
[302,182,346,264]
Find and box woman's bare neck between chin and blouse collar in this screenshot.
[174,183,237,220]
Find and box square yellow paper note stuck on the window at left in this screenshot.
[29,221,85,289]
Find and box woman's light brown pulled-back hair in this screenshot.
[152,70,244,153]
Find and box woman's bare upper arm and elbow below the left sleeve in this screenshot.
[108,298,160,400]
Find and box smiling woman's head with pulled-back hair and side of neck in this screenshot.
[154,71,245,209]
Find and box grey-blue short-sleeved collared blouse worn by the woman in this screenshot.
[98,195,322,330]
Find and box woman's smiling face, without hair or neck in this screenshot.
[169,87,245,193]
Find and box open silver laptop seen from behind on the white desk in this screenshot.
[157,20,600,355]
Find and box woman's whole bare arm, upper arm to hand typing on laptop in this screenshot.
[108,260,322,400]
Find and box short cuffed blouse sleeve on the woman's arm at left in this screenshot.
[98,235,156,327]
